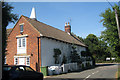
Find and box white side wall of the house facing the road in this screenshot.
[41,38,85,66]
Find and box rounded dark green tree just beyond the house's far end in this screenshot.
[84,34,108,60]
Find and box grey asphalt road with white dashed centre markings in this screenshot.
[44,64,118,80]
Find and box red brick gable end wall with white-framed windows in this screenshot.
[6,16,41,70]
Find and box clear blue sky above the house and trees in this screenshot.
[7,2,118,38]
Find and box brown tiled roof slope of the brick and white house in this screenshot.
[23,16,86,47]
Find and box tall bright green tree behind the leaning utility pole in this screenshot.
[100,4,120,56]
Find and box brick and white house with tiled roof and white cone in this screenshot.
[6,7,86,71]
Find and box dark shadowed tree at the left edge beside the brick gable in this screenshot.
[2,2,18,64]
